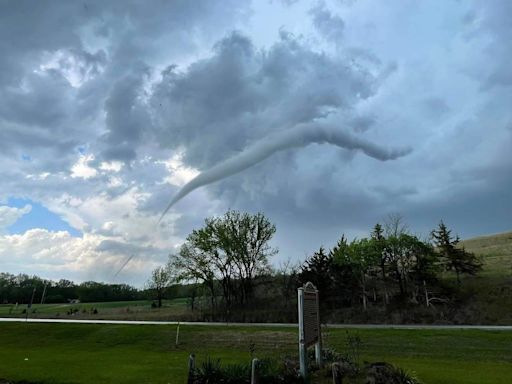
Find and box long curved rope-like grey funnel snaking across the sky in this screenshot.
[158,123,412,222]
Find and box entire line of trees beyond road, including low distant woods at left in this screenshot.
[0,210,482,321]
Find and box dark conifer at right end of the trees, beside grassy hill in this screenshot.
[432,221,482,286]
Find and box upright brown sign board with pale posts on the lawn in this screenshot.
[297,282,322,380]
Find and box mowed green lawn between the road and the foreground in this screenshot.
[0,323,512,384]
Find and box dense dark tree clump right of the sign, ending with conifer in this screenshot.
[298,216,482,311]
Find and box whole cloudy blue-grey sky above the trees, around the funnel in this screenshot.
[0,0,512,286]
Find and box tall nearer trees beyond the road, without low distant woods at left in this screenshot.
[154,211,482,320]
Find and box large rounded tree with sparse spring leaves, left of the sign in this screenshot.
[170,211,277,312]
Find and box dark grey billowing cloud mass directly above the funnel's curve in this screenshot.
[152,32,378,168]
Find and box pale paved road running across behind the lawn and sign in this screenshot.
[0,317,512,331]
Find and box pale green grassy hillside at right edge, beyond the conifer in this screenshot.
[461,232,512,276]
